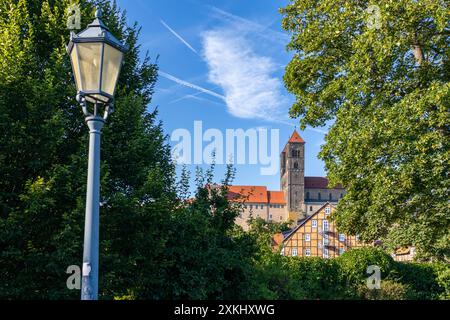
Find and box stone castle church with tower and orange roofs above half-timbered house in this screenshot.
[229,131,345,230]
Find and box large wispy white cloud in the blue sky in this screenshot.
[203,29,289,120]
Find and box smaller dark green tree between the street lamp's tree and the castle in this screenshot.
[158,166,257,299]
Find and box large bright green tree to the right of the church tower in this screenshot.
[281,0,450,259]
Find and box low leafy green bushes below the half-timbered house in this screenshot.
[252,247,444,300]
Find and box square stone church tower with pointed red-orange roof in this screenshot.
[280,130,305,222]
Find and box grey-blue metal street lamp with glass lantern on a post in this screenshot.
[67,10,128,300]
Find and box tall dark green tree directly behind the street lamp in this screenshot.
[0,0,177,299]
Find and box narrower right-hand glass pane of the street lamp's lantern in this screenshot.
[102,44,123,95]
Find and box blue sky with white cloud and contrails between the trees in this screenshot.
[118,0,326,190]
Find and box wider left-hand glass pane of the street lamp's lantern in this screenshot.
[75,43,102,91]
